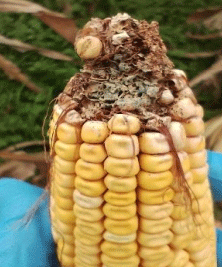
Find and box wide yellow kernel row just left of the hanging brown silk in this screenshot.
[137,125,180,267]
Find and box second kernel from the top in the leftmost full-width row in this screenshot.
[54,140,80,161]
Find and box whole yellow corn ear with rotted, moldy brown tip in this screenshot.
[49,14,216,267]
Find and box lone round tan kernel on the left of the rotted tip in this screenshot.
[74,36,103,59]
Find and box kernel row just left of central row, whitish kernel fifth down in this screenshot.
[74,121,108,267]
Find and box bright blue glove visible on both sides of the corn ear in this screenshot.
[0,151,222,267]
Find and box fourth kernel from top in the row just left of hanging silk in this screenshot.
[138,187,175,205]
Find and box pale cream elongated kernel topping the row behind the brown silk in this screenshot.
[169,121,186,151]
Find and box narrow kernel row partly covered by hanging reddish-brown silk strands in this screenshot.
[170,122,194,267]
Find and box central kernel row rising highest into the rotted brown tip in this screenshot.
[101,114,140,267]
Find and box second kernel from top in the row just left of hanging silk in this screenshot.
[139,153,173,172]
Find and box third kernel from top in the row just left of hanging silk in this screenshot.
[137,171,173,190]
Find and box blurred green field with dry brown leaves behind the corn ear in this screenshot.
[0,0,222,186]
